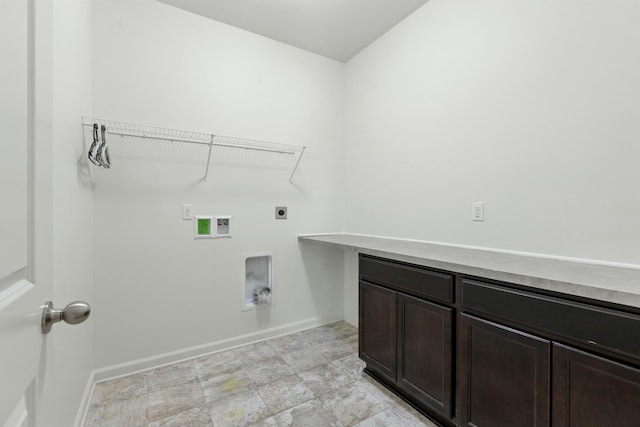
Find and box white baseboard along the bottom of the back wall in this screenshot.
[90,315,343,384]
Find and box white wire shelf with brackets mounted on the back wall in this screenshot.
[82,117,307,182]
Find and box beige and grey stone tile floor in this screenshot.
[85,322,435,427]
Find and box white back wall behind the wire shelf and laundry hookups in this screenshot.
[93,0,344,367]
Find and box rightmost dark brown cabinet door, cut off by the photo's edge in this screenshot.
[553,344,640,427]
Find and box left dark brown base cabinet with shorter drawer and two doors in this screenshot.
[359,257,454,419]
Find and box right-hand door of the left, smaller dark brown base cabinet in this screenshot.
[398,293,453,418]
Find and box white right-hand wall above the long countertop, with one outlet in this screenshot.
[346,0,640,264]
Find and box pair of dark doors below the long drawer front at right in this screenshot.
[459,314,640,427]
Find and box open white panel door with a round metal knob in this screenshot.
[0,0,51,427]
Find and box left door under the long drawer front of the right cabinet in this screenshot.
[460,314,552,427]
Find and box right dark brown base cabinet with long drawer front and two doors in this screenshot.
[460,279,640,427]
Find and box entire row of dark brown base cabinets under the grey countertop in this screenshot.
[359,255,640,427]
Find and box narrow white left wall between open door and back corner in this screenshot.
[40,0,94,426]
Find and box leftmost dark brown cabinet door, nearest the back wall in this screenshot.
[359,281,398,383]
